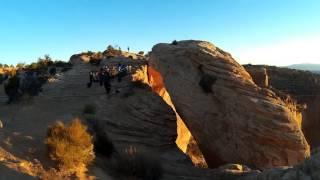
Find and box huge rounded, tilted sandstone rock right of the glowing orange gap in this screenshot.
[149,41,310,168]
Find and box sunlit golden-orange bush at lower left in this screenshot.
[45,119,95,170]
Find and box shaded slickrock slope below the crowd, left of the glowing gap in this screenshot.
[0,57,218,180]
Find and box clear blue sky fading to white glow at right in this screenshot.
[0,0,320,65]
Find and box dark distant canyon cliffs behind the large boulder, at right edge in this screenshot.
[245,65,320,149]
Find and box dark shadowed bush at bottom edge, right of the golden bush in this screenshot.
[113,148,163,180]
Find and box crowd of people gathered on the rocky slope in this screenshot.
[87,63,128,94]
